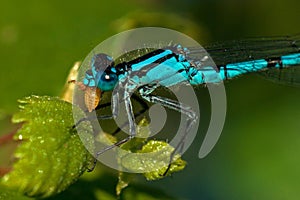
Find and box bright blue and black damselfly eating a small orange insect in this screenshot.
[75,32,300,173]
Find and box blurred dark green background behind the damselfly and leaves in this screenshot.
[0,0,300,200]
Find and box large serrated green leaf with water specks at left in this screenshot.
[3,96,93,197]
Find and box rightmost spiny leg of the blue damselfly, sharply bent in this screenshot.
[140,89,197,176]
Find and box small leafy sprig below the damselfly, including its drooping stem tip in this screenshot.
[96,118,186,196]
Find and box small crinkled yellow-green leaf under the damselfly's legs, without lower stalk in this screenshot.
[119,119,186,181]
